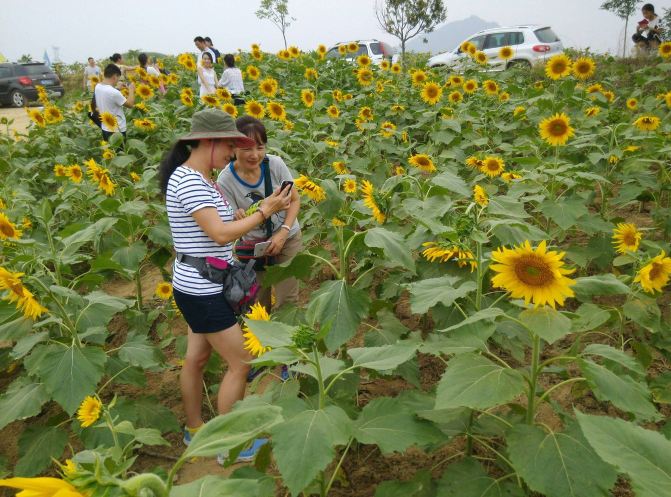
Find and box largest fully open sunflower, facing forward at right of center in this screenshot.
[490,240,575,308]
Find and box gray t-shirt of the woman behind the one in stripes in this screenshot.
[217,154,300,240]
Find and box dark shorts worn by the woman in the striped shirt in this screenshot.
[173,290,238,333]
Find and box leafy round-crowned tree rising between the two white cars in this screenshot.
[375,0,446,61]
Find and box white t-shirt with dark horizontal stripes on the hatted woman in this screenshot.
[165,166,233,295]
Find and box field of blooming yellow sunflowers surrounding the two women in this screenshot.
[0,43,671,497]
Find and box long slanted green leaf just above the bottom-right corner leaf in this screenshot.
[579,359,660,421]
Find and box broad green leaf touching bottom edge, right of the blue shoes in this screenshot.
[271,406,352,496]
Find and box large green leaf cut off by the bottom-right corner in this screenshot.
[576,412,671,497]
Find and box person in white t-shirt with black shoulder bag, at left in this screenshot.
[93,64,135,141]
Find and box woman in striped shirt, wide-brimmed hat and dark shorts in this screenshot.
[160,109,291,458]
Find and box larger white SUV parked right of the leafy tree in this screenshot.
[428,25,564,71]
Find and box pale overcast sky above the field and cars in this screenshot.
[0,0,671,62]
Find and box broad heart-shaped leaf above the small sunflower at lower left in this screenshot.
[26,345,107,415]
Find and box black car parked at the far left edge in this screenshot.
[0,62,65,107]
